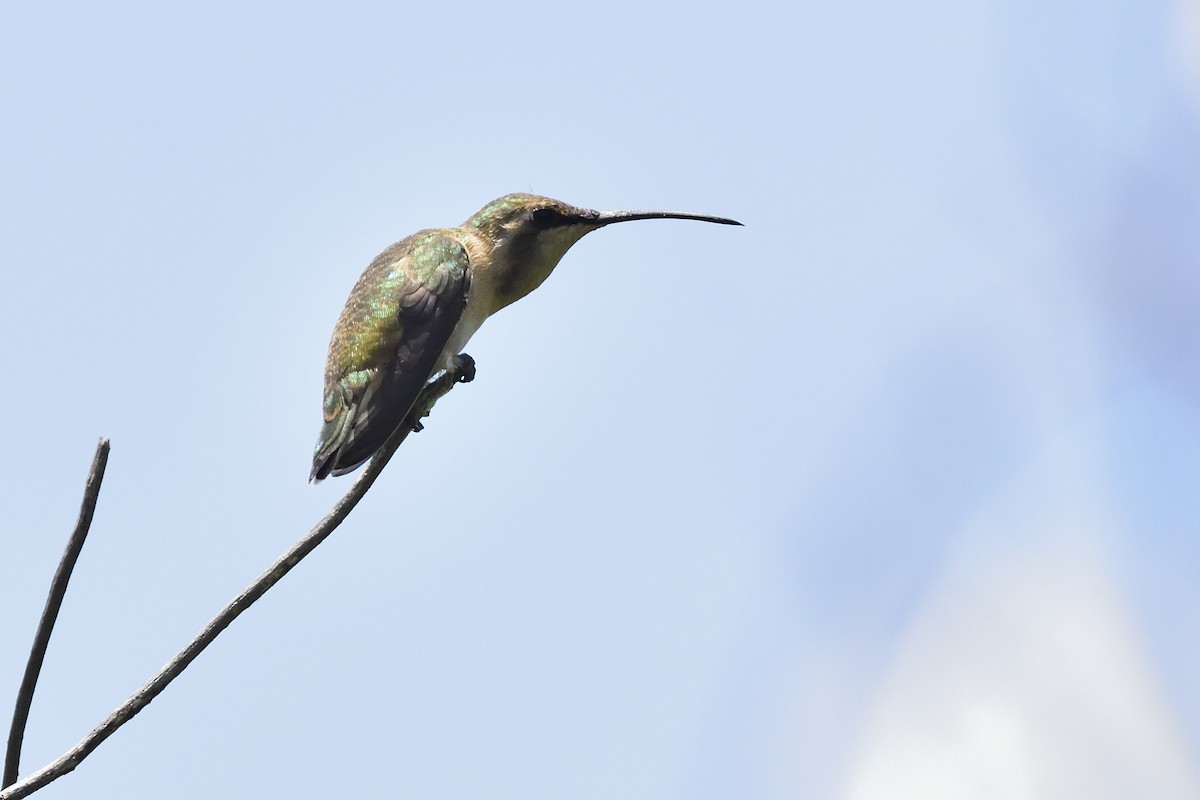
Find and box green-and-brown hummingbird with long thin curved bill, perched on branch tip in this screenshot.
[310,194,742,482]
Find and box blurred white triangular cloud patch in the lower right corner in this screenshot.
[844,435,1200,800]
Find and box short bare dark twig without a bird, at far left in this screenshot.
[0,439,108,788]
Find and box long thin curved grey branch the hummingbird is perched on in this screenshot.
[0,356,465,800]
